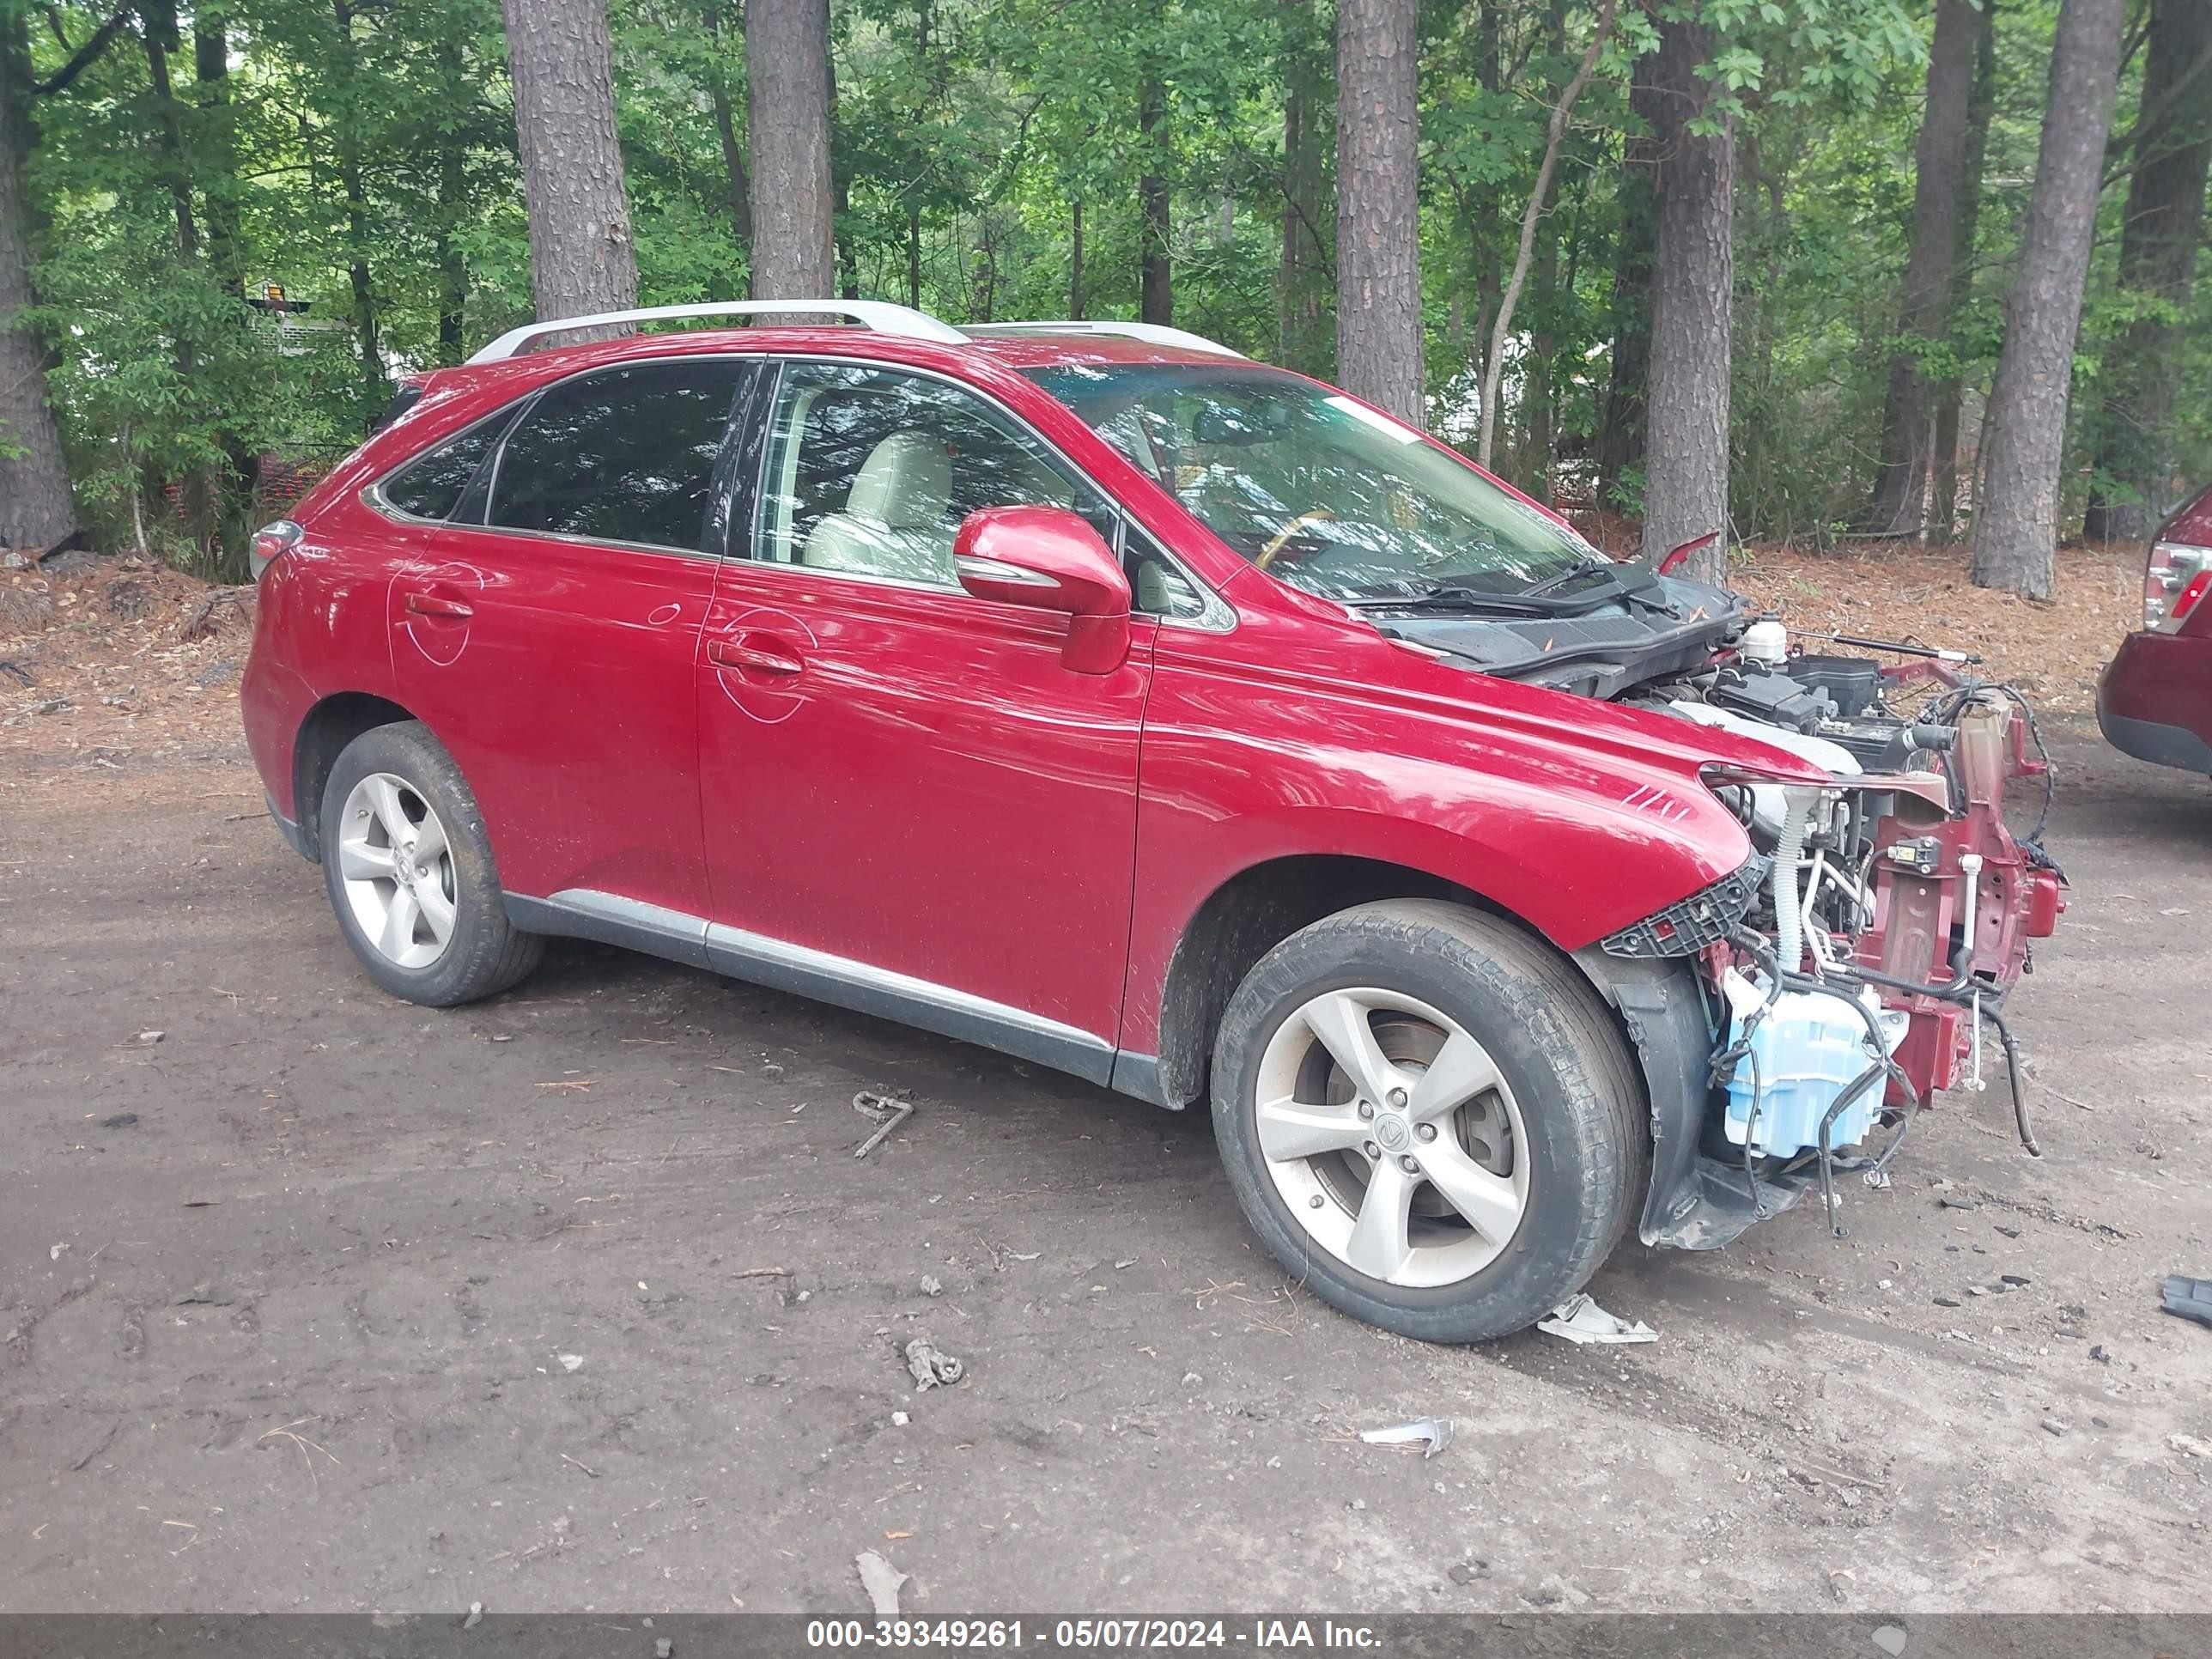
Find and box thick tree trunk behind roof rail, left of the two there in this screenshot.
[504,0,641,321]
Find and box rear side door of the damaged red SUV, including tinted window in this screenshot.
[387,358,754,922]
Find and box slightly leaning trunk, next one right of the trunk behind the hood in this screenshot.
[1867,0,1980,535]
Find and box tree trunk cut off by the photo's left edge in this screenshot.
[0,53,77,553]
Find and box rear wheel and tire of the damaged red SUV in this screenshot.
[321,721,544,1009]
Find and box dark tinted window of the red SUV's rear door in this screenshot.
[489,358,745,553]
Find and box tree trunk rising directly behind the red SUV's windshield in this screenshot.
[1336,0,1425,425]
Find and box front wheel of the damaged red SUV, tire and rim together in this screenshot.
[1212,900,1650,1343]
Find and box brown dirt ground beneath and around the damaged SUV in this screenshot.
[0,553,2212,1614]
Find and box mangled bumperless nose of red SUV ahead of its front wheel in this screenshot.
[1575,664,2063,1249]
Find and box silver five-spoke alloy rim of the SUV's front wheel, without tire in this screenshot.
[1255,987,1528,1287]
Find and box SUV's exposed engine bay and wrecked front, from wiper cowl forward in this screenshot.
[1370,566,2063,1248]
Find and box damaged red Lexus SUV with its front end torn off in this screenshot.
[246,301,2057,1340]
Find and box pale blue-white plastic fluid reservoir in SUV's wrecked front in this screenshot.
[1721,969,1909,1157]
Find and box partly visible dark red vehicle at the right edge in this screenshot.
[2097,489,2212,772]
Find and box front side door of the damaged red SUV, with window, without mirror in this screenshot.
[699,362,1152,1082]
